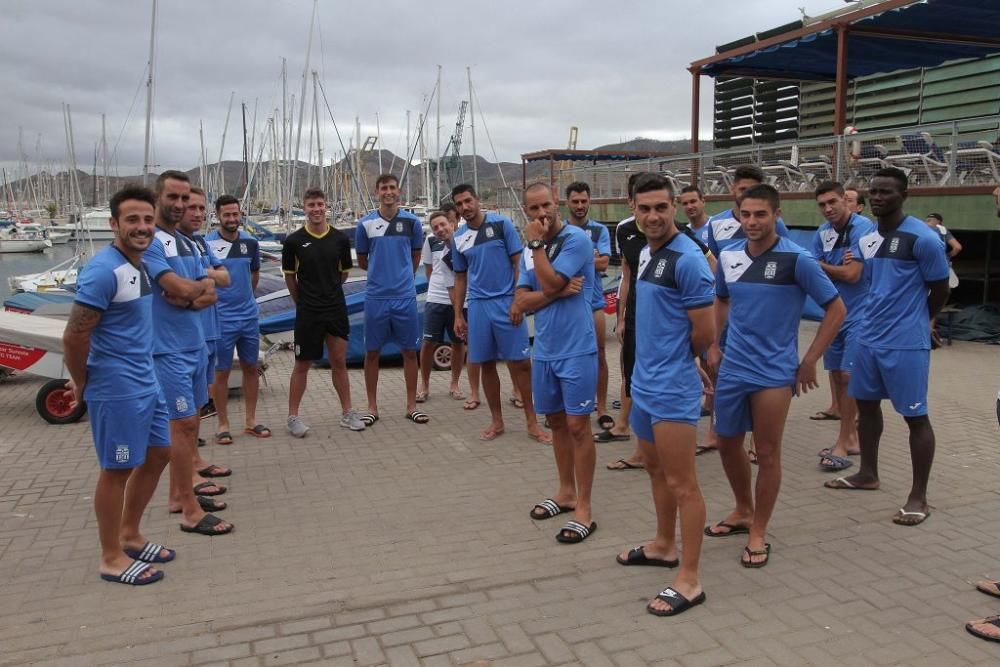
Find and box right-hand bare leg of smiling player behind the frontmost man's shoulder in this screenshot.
[747,387,792,551]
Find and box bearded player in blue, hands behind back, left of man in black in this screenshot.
[205,195,271,445]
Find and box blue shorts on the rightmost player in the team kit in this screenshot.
[847,345,931,417]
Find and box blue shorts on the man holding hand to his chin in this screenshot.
[531,352,597,415]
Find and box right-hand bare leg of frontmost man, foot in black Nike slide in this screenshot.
[650,422,705,610]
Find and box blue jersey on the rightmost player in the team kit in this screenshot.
[860,216,948,350]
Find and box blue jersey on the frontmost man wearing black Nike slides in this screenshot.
[632,233,715,396]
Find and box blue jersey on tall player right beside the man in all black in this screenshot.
[354,209,424,299]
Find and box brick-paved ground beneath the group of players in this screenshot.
[0,324,1000,667]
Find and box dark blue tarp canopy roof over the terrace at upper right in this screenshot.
[701,0,1000,81]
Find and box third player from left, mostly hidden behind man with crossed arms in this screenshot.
[177,186,232,470]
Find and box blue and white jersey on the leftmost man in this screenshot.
[74,245,160,401]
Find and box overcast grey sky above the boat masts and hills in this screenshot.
[0,0,844,175]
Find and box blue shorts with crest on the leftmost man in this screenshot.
[87,394,170,470]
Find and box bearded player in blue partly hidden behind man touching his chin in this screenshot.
[566,181,615,431]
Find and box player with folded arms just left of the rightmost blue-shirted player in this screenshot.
[811,181,875,471]
